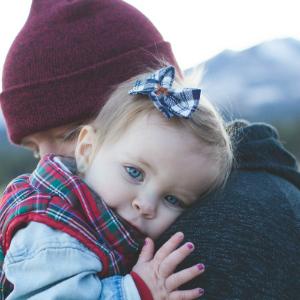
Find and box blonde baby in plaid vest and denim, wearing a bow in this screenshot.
[0,66,232,299]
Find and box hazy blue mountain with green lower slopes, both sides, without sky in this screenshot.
[0,38,300,190]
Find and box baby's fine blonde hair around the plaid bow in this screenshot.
[91,70,233,194]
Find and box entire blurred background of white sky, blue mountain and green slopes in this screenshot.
[0,0,300,190]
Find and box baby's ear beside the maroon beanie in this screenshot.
[75,125,97,174]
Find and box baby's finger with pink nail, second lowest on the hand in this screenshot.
[166,264,205,291]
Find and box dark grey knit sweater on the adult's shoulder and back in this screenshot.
[158,121,300,300]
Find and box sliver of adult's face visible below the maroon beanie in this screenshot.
[22,124,76,157]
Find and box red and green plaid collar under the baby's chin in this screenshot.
[29,154,145,273]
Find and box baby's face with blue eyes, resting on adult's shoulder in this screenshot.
[84,114,216,239]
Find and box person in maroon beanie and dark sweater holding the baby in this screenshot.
[0,0,300,299]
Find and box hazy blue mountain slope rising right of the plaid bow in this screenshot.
[195,38,300,122]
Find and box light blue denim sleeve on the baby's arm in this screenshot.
[3,222,140,300]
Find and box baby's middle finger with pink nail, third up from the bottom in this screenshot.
[159,242,194,277]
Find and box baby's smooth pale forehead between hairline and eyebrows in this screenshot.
[120,114,211,163]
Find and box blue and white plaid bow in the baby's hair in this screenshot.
[128,66,201,119]
